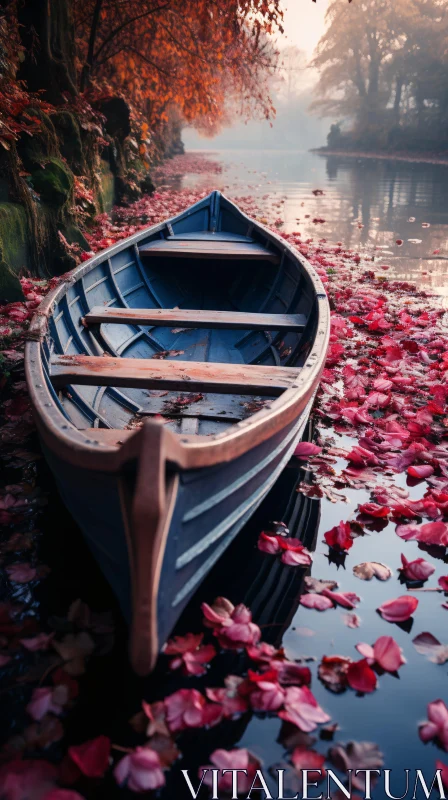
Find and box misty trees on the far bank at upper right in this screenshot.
[312,0,448,152]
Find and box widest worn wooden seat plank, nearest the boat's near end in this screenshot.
[50,355,300,396]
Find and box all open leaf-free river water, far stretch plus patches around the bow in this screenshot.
[0,151,448,800]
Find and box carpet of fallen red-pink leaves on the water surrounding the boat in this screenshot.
[0,157,448,800]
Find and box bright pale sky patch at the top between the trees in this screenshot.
[283,0,329,56]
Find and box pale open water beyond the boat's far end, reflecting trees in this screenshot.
[183,150,448,302]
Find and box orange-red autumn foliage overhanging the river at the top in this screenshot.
[74,0,281,131]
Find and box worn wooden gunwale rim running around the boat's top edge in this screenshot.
[25,193,330,472]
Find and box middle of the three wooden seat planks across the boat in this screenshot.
[84,306,306,331]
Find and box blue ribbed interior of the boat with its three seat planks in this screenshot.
[42,192,316,436]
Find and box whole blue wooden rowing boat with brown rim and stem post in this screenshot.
[25,192,329,674]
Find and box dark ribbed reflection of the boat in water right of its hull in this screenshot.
[159,454,320,798]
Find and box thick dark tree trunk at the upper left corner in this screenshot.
[18,0,77,105]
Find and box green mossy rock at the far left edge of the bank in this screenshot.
[0,203,29,302]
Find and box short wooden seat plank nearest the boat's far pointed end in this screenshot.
[139,239,280,264]
